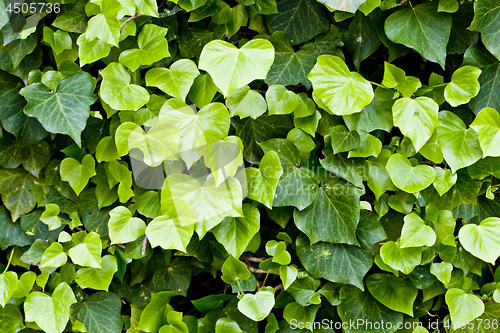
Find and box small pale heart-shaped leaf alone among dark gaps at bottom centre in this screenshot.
[238,287,274,321]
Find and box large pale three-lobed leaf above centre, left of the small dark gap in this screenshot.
[159,98,230,168]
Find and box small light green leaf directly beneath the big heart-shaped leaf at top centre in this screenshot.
[226,86,267,119]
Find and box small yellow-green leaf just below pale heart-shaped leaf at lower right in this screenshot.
[380,241,424,274]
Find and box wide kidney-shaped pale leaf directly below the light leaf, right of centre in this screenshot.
[386,154,436,193]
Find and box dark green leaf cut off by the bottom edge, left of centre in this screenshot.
[73,292,123,333]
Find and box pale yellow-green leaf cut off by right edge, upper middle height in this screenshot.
[470,108,500,157]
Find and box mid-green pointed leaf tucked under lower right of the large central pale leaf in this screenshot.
[211,204,260,258]
